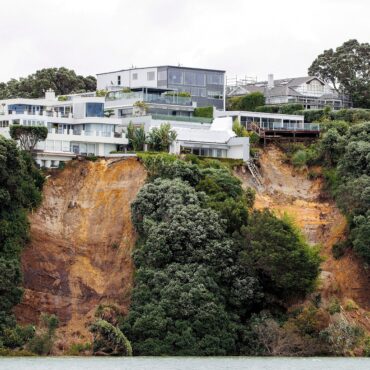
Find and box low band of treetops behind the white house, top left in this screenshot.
[0,67,96,99]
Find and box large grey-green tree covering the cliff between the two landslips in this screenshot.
[122,176,260,355]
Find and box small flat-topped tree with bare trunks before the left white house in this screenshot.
[10,125,48,152]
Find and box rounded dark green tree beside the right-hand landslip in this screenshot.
[242,209,321,300]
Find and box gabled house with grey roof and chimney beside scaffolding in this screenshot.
[227,74,352,110]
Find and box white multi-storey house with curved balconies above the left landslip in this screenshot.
[0,90,128,167]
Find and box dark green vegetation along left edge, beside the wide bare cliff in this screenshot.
[0,136,43,348]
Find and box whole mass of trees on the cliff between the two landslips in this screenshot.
[119,154,320,355]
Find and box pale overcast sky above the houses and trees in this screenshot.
[0,0,370,81]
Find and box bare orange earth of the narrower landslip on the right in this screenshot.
[237,147,370,330]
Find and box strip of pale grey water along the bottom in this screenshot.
[0,357,370,370]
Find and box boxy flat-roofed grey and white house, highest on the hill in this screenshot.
[97,66,225,109]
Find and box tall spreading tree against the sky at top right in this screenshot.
[308,40,370,108]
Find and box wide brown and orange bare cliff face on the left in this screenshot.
[15,158,146,336]
